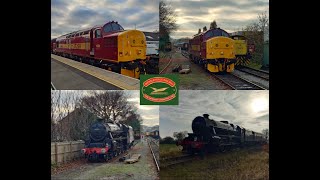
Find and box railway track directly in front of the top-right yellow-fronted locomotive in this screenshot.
[212,74,265,90]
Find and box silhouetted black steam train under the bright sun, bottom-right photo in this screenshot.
[178,114,267,154]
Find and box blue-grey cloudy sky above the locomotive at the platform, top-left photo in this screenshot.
[51,0,159,38]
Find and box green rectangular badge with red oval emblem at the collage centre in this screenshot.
[140,74,179,105]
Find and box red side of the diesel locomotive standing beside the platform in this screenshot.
[57,21,124,63]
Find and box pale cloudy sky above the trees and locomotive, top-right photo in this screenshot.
[166,0,269,39]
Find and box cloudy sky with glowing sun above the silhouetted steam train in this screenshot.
[160,90,269,137]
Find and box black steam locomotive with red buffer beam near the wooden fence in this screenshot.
[82,119,134,162]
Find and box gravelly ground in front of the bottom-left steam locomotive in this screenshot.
[51,141,159,180]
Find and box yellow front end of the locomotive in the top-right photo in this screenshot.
[206,36,236,72]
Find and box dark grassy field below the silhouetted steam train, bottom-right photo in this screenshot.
[160,144,269,180]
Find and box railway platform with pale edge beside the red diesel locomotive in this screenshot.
[51,54,140,90]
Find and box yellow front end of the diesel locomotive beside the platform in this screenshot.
[118,30,147,78]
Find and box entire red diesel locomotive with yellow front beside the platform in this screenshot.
[54,21,157,78]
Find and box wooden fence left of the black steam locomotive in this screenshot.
[51,141,84,164]
